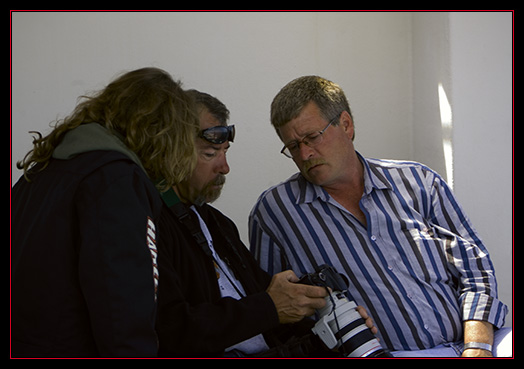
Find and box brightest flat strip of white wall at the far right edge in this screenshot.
[450,13,513,324]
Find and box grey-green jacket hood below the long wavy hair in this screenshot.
[53,123,147,174]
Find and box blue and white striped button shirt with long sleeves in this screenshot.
[249,155,507,350]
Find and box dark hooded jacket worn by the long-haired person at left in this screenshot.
[11,124,162,357]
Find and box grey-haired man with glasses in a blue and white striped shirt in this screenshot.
[249,76,511,356]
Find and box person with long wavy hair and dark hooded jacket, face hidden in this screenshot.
[11,68,199,357]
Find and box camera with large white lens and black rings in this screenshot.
[298,264,392,357]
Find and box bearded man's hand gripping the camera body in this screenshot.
[266,270,327,324]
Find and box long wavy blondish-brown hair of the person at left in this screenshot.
[17,68,199,190]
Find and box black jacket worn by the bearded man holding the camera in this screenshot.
[157,198,322,357]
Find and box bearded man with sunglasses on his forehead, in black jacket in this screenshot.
[157,90,372,357]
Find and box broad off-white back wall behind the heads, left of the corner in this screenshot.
[13,13,412,236]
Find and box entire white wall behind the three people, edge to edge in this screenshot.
[12,12,512,324]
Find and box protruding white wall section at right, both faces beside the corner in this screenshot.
[412,12,513,325]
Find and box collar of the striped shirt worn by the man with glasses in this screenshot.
[296,152,392,204]
